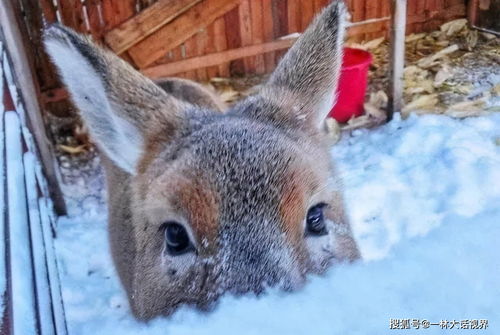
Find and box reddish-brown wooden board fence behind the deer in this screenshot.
[11,0,466,118]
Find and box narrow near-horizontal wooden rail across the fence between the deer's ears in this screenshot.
[141,38,296,79]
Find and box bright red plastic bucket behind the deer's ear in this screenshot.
[328,48,372,123]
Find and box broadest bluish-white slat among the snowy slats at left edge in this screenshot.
[5,111,38,335]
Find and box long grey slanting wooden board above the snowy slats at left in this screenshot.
[0,1,66,215]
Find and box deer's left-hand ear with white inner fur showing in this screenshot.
[45,24,186,174]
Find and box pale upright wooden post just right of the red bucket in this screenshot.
[388,0,406,120]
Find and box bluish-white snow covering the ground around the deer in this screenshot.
[56,113,500,335]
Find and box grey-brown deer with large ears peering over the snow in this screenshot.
[45,2,359,320]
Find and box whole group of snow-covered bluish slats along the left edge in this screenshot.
[0,38,67,335]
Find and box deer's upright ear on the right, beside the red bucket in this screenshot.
[235,1,347,131]
